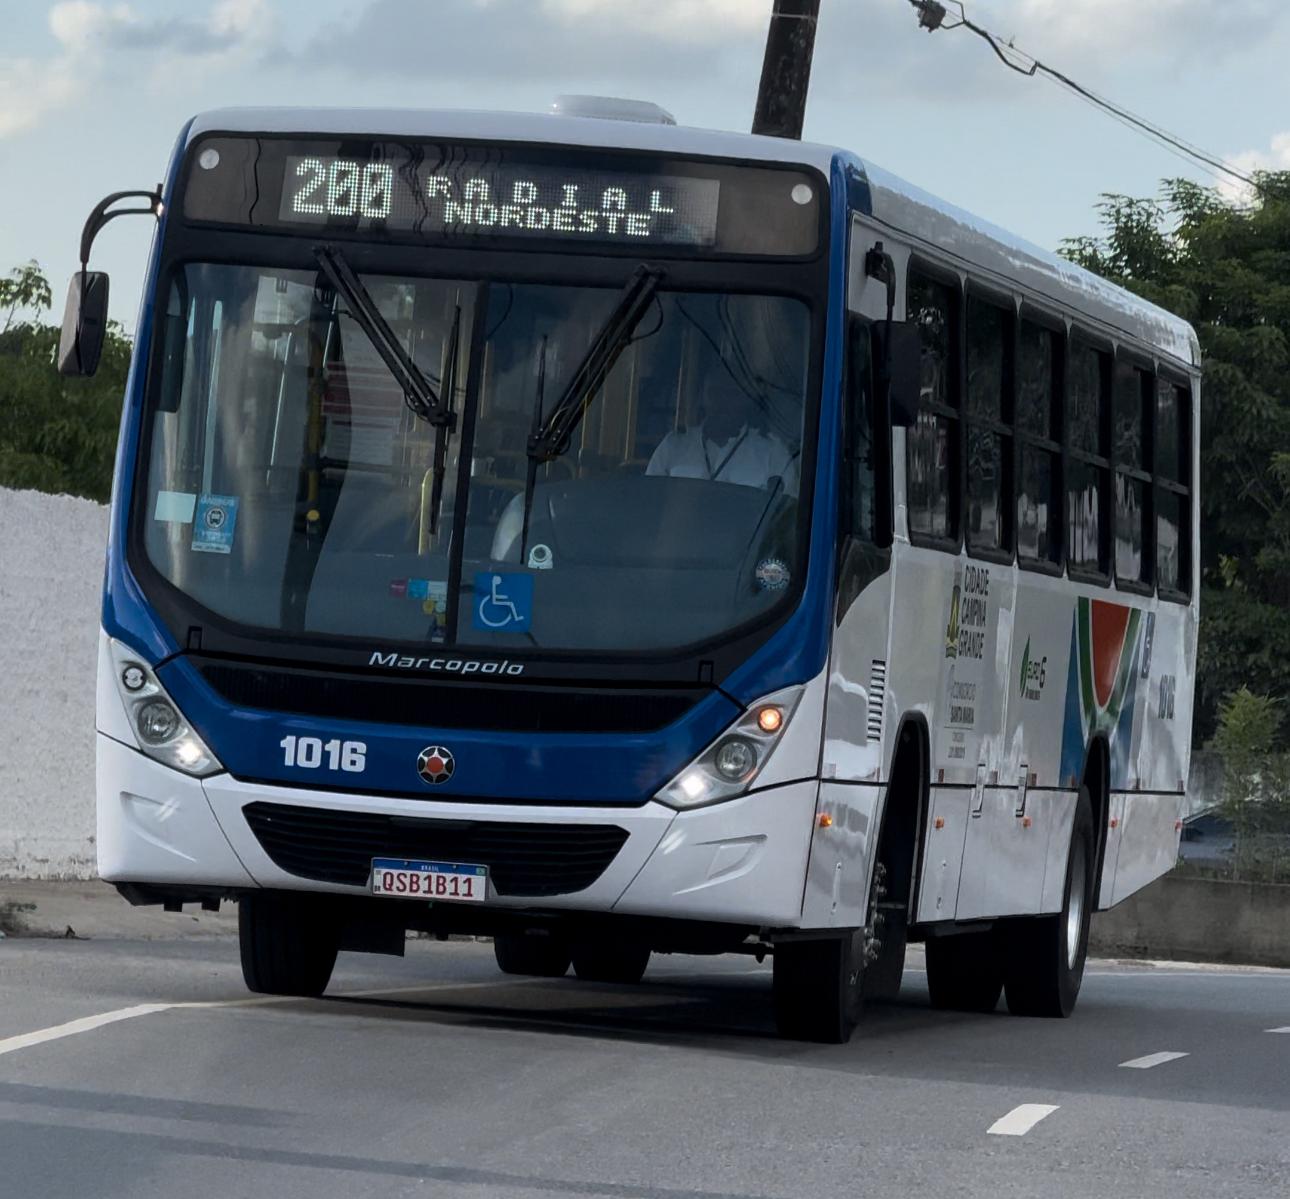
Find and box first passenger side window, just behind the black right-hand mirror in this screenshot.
[906,274,958,541]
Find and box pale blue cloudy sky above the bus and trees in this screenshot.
[0,0,1290,328]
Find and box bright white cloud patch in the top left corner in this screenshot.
[0,0,273,138]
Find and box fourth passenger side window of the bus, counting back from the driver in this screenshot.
[1066,341,1111,574]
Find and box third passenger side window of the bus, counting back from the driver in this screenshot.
[1017,320,1062,564]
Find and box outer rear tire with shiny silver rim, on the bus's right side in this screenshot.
[998,787,1097,1018]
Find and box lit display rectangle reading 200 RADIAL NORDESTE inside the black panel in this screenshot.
[279,155,721,245]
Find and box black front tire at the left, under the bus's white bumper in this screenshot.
[237,892,338,998]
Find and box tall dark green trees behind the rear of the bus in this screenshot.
[1063,172,1290,741]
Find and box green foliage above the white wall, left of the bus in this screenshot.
[0,262,130,502]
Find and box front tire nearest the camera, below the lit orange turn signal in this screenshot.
[774,929,864,1045]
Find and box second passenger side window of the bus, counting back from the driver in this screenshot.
[968,297,1013,554]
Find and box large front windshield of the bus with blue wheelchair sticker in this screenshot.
[137,263,811,653]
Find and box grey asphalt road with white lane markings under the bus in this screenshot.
[0,937,1290,1199]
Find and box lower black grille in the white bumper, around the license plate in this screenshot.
[243,801,627,897]
